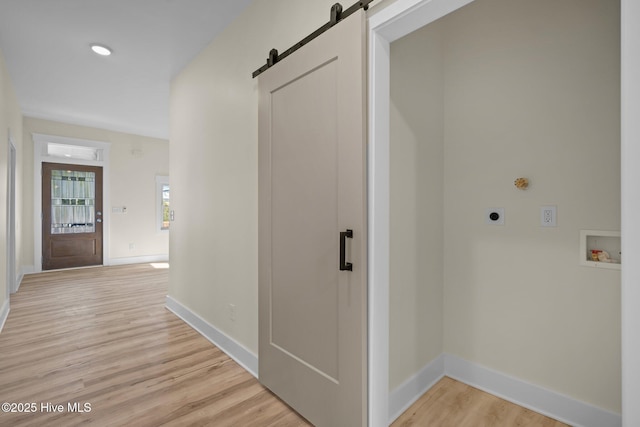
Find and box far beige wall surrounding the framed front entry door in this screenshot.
[23,117,169,265]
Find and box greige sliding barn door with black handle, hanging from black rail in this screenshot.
[258,10,367,427]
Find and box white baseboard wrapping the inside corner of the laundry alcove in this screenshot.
[389,353,622,427]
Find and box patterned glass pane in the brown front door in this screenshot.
[51,170,96,234]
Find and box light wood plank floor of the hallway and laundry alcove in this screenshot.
[0,264,564,427]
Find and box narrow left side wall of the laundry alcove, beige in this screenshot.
[389,23,444,390]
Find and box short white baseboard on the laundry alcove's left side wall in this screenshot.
[389,354,445,424]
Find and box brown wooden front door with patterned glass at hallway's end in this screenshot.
[42,163,102,270]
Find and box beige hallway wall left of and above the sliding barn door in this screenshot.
[169,0,350,354]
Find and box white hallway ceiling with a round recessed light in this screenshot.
[0,0,252,139]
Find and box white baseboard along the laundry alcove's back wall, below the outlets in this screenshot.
[445,354,622,427]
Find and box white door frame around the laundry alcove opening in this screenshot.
[368,0,640,427]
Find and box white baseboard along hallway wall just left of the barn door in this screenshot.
[166,296,258,378]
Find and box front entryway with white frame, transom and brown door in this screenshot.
[33,134,110,272]
